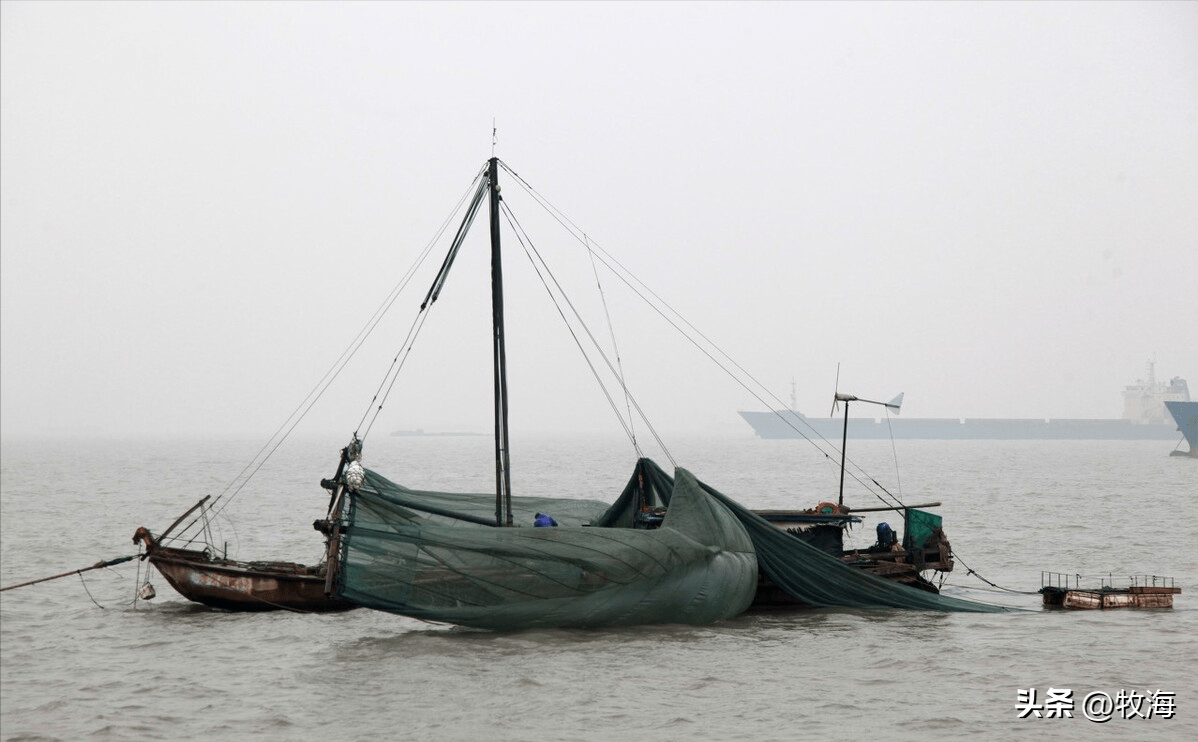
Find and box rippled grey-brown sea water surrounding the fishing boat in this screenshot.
[0,438,1198,741]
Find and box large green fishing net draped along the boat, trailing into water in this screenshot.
[338,459,1004,631]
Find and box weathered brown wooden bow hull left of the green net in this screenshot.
[149,547,355,613]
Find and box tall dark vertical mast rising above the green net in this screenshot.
[486,157,512,526]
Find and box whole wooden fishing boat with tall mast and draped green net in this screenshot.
[121,157,1000,631]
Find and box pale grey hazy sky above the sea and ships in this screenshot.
[0,1,1198,435]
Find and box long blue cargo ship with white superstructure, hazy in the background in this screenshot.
[740,362,1198,441]
